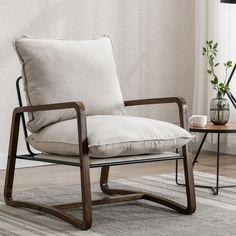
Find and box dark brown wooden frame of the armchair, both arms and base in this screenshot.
[4,78,196,230]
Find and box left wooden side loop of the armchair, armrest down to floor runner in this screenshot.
[4,102,92,229]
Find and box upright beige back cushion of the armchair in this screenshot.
[13,36,125,132]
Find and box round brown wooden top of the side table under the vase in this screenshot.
[189,122,236,133]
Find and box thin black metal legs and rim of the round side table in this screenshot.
[175,129,236,195]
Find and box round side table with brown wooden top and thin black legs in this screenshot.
[176,123,236,195]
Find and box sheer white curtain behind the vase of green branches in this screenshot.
[193,0,236,146]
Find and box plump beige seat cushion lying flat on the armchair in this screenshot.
[28,115,193,158]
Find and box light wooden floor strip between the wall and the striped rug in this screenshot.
[0,152,236,192]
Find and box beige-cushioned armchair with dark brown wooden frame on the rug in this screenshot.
[4,36,196,229]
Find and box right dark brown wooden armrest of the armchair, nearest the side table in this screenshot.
[124,97,188,130]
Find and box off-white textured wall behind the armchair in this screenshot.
[0,0,195,168]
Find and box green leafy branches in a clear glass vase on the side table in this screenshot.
[202,40,233,125]
